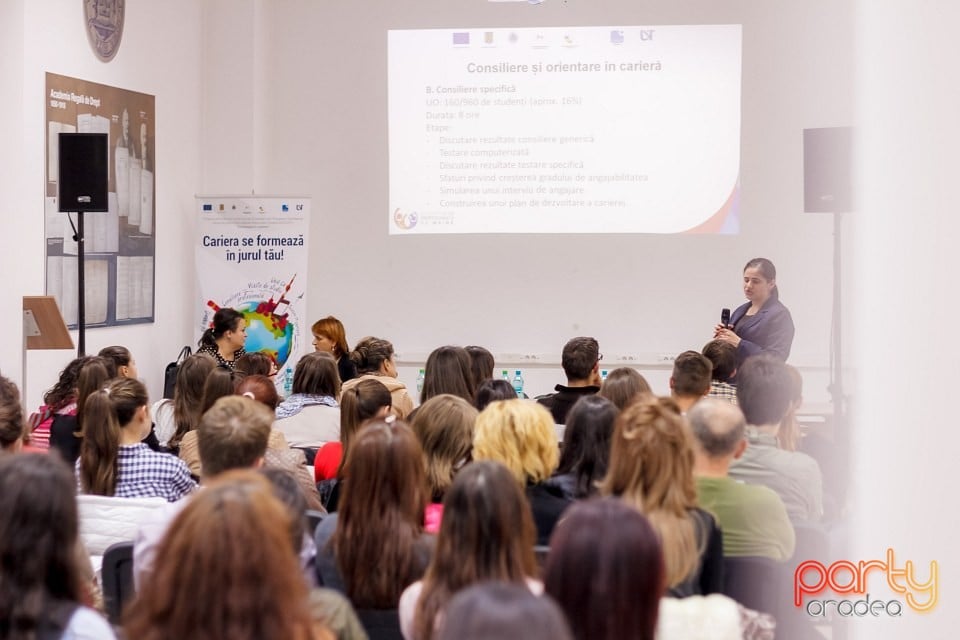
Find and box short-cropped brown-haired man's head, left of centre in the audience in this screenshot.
[197,395,274,477]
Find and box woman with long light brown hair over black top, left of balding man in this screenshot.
[600,397,723,597]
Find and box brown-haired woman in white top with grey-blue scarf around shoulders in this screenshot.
[274,351,340,448]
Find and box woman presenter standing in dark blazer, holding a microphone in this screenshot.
[713,258,793,368]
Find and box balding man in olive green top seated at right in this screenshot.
[687,398,795,560]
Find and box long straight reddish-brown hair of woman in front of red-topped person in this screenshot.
[330,421,427,609]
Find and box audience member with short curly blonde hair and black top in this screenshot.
[473,399,571,544]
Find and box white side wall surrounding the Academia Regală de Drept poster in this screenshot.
[6,0,202,409]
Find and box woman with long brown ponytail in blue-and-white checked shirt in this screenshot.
[76,378,196,502]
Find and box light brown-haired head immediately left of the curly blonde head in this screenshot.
[410,393,479,501]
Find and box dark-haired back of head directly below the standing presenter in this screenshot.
[737,354,793,425]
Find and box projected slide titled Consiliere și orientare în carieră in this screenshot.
[388,25,741,234]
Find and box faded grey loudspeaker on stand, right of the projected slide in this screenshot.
[803,127,853,213]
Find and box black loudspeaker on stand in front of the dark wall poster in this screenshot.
[57,133,108,211]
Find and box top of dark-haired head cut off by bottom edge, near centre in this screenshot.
[437,582,573,640]
